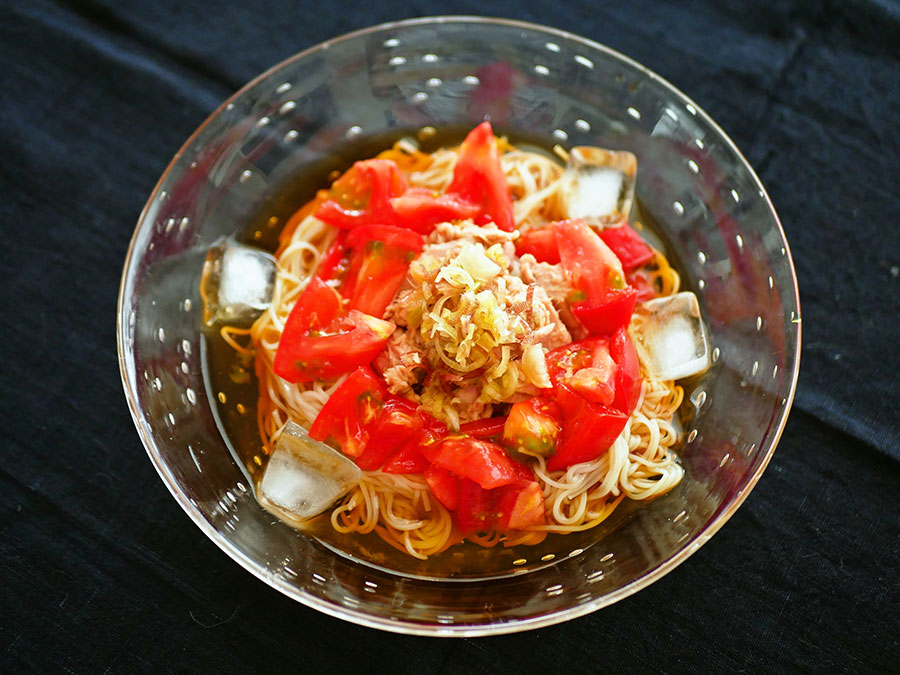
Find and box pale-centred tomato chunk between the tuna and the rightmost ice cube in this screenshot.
[547,338,616,404]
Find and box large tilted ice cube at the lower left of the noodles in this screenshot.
[256,422,362,526]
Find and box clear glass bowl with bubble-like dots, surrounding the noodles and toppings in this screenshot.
[118,17,800,635]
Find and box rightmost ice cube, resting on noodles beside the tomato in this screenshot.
[634,292,710,380]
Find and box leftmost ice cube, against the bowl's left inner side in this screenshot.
[200,241,275,324]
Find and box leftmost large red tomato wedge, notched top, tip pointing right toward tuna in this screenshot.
[272,277,394,382]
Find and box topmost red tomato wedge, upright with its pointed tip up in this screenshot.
[447,122,515,232]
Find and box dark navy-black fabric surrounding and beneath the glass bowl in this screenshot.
[0,0,900,673]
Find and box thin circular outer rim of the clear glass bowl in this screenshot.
[116,15,802,637]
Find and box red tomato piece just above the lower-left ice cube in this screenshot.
[309,366,385,457]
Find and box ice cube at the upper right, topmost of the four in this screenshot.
[562,146,637,225]
